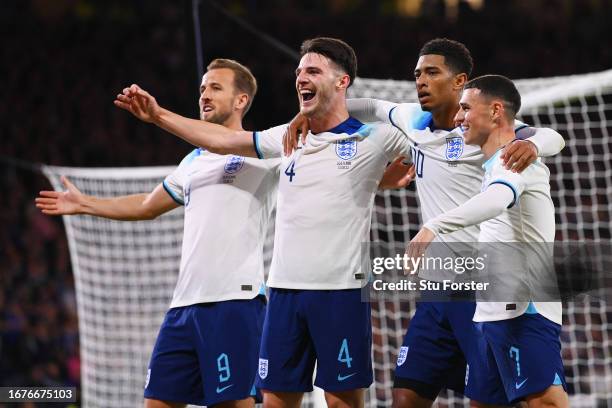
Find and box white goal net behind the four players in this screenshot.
[44,71,612,407]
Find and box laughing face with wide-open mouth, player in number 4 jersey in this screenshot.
[295,53,350,117]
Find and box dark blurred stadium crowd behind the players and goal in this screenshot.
[0,0,612,406]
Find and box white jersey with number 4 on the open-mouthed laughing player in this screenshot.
[253,118,410,290]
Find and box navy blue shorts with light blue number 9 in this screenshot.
[144,296,266,405]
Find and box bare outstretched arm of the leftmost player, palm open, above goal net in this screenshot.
[35,177,179,221]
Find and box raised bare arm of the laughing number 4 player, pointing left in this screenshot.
[115,85,257,157]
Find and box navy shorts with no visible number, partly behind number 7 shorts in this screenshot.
[394,301,476,400]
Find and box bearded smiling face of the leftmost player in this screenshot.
[199,68,239,125]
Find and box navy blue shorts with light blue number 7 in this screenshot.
[466,313,567,404]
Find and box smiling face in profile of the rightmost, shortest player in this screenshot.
[455,88,495,146]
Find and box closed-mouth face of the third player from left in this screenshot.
[414,54,467,113]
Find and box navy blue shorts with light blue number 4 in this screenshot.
[256,288,372,392]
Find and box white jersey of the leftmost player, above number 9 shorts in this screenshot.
[163,149,280,308]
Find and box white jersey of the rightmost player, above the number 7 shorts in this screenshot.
[474,151,562,324]
